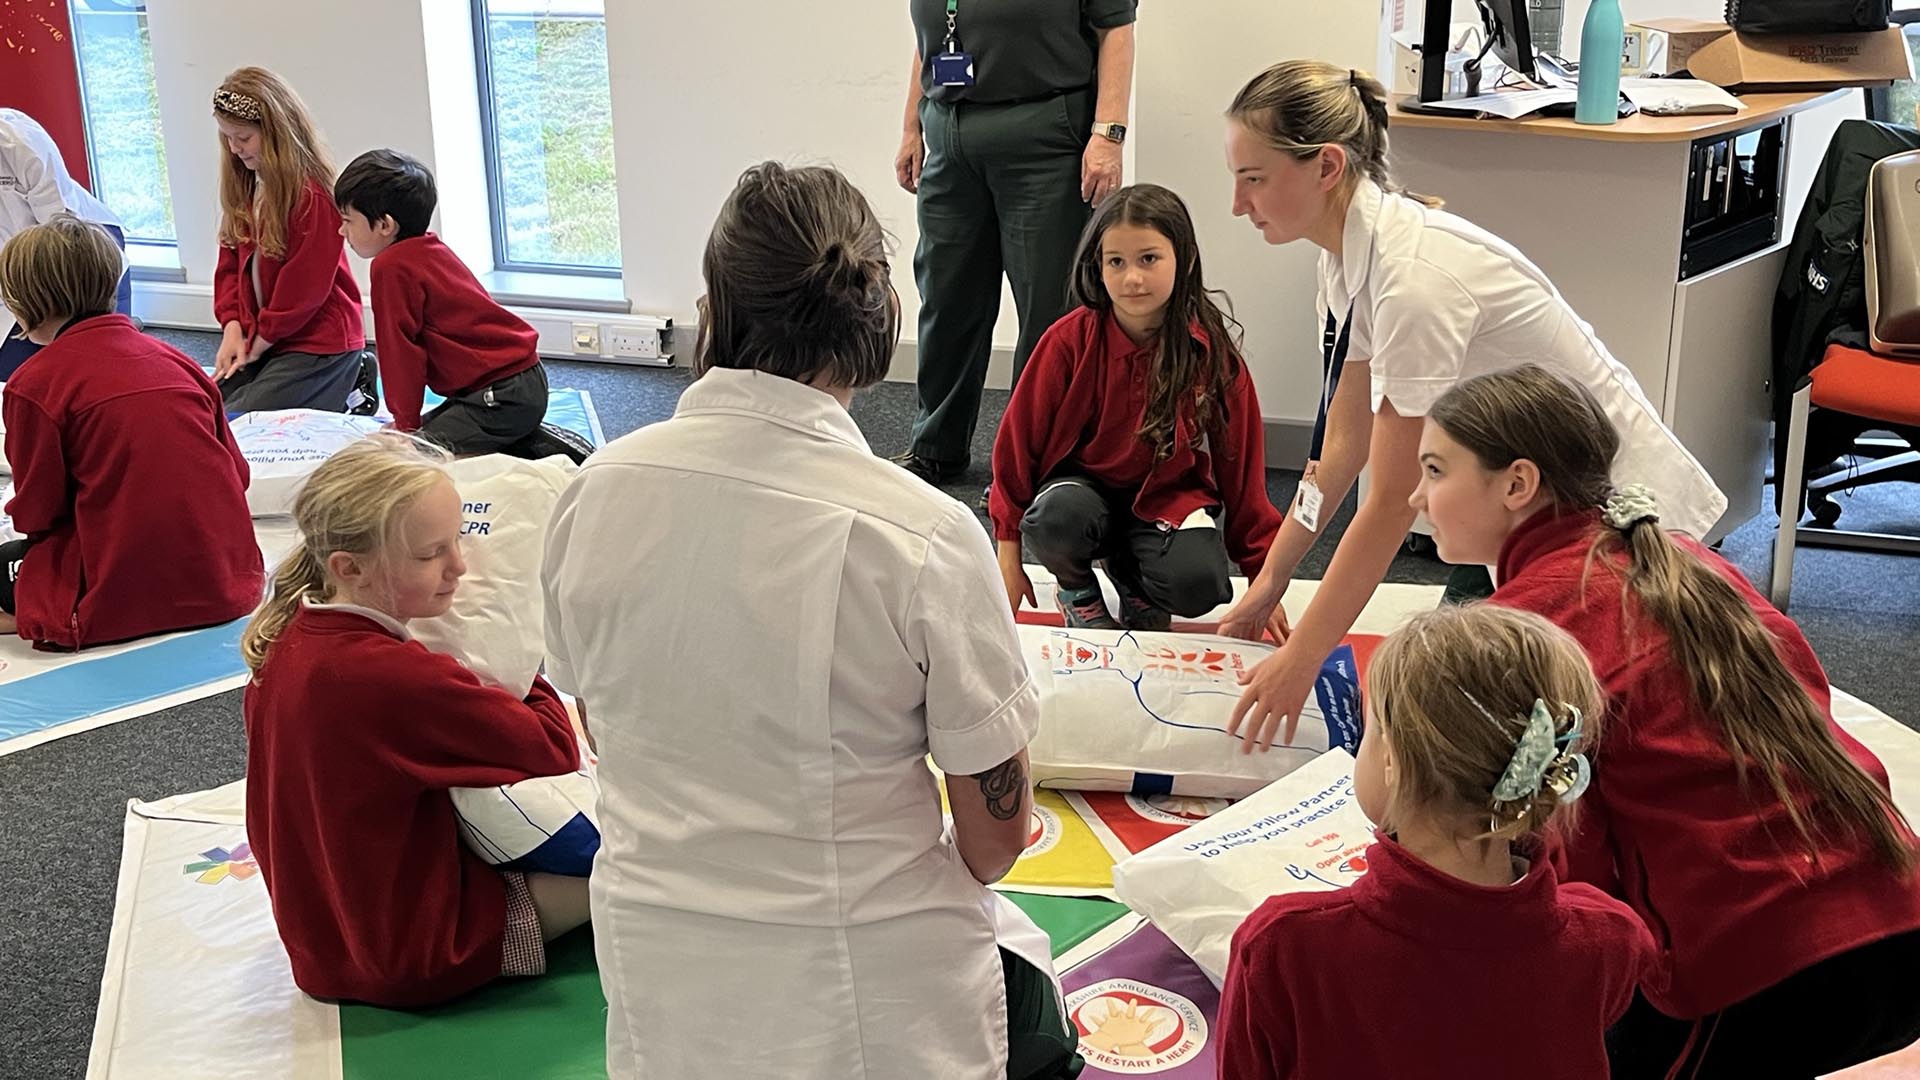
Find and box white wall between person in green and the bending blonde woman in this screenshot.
[1135,0,1380,421]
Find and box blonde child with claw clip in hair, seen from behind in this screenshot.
[1219,605,1659,1080]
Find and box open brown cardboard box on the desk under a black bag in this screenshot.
[1640,19,1914,90]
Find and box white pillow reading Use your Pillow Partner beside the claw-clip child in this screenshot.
[1114,749,1373,984]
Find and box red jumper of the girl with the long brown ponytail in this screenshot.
[1492,511,1920,1020]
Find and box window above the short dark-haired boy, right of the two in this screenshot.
[472,0,620,277]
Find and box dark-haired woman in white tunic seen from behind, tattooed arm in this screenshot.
[543,163,1077,1080]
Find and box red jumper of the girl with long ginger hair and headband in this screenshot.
[213,181,367,356]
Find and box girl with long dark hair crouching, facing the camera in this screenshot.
[989,184,1281,630]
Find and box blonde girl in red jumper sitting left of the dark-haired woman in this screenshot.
[242,434,588,1007]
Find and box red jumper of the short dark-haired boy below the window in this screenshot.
[372,233,540,430]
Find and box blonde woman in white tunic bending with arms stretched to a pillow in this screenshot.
[1223,60,1726,749]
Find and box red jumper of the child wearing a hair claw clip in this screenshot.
[1217,834,1659,1080]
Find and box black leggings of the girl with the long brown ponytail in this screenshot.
[1607,930,1920,1080]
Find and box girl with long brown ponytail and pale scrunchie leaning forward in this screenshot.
[1413,367,1920,1080]
